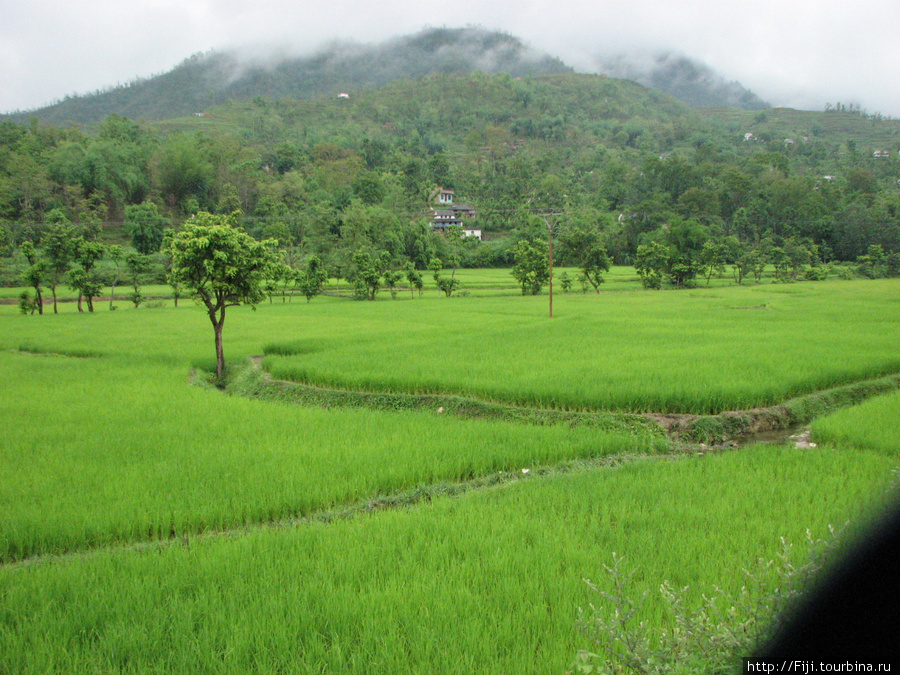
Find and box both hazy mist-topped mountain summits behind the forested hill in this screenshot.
[0,27,766,125]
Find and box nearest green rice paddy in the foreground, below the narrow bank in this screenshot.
[0,447,893,673]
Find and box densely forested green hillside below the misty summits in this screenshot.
[0,67,900,298]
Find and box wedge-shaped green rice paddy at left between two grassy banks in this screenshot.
[0,354,665,561]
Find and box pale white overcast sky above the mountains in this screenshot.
[0,0,900,117]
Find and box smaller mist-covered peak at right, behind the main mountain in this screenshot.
[599,52,771,110]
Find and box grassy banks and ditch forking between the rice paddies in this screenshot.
[3,357,900,567]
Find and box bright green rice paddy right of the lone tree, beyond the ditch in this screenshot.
[265,280,900,413]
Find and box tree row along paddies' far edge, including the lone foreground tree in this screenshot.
[15,211,900,390]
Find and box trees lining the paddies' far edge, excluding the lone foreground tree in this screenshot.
[20,203,900,320]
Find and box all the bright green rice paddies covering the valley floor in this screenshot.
[0,274,900,673]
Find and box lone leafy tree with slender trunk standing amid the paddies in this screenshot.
[167,211,278,382]
